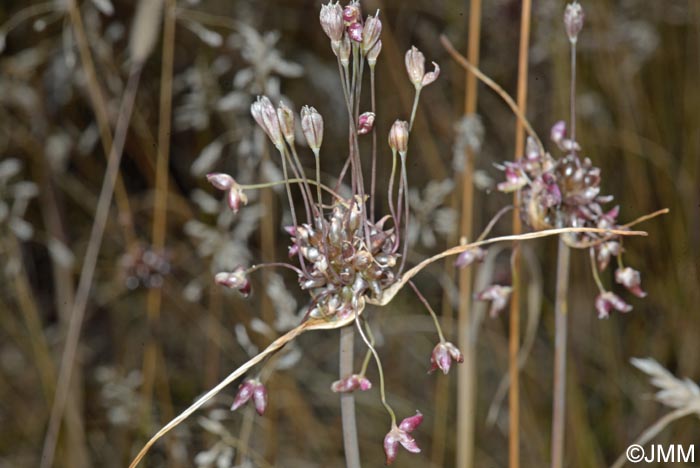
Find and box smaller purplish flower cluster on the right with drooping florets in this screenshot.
[498,121,646,318]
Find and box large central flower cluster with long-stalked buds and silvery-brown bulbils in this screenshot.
[200,2,454,462]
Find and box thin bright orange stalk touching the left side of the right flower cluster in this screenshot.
[508,0,532,468]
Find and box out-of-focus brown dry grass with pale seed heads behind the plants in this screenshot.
[0,0,700,468]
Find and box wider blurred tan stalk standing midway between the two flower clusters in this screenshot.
[456,0,481,468]
